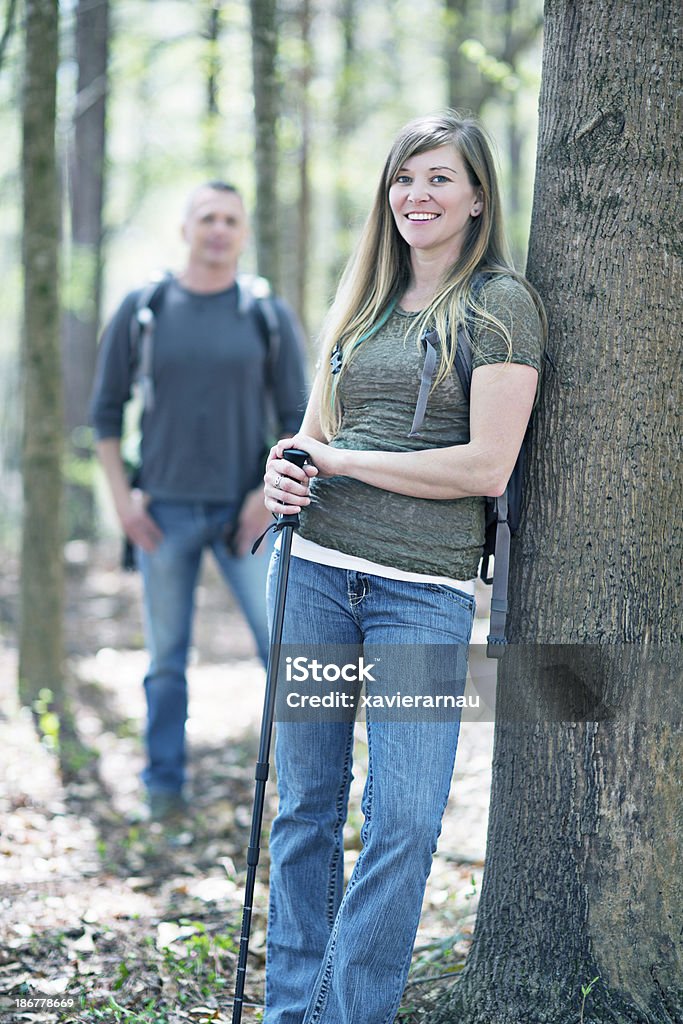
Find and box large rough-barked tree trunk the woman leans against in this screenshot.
[433,0,683,1024]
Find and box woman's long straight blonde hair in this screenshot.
[321,110,546,437]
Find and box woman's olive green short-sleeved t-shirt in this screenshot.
[300,276,542,580]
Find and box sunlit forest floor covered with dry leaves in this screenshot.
[0,545,493,1024]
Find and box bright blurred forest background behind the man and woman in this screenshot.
[0,0,543,555]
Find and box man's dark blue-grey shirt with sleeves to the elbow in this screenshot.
[91,278,306,503]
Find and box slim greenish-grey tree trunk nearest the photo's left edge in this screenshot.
[19,0,63,703]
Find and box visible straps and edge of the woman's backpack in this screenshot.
[411,272,552,658]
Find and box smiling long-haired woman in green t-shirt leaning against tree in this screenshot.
[264,111,545,1024]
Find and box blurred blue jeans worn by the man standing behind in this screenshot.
[137,501,268,794]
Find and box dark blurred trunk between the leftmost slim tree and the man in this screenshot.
[62,0,109,538]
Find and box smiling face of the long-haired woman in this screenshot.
[389,145,483,261]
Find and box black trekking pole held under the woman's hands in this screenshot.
[232,449,308,1024]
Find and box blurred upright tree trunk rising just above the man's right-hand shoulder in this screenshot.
[250,0,280,289]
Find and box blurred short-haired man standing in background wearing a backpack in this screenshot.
[91,181,305,819]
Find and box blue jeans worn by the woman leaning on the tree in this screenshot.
[264,552,474,1024]
